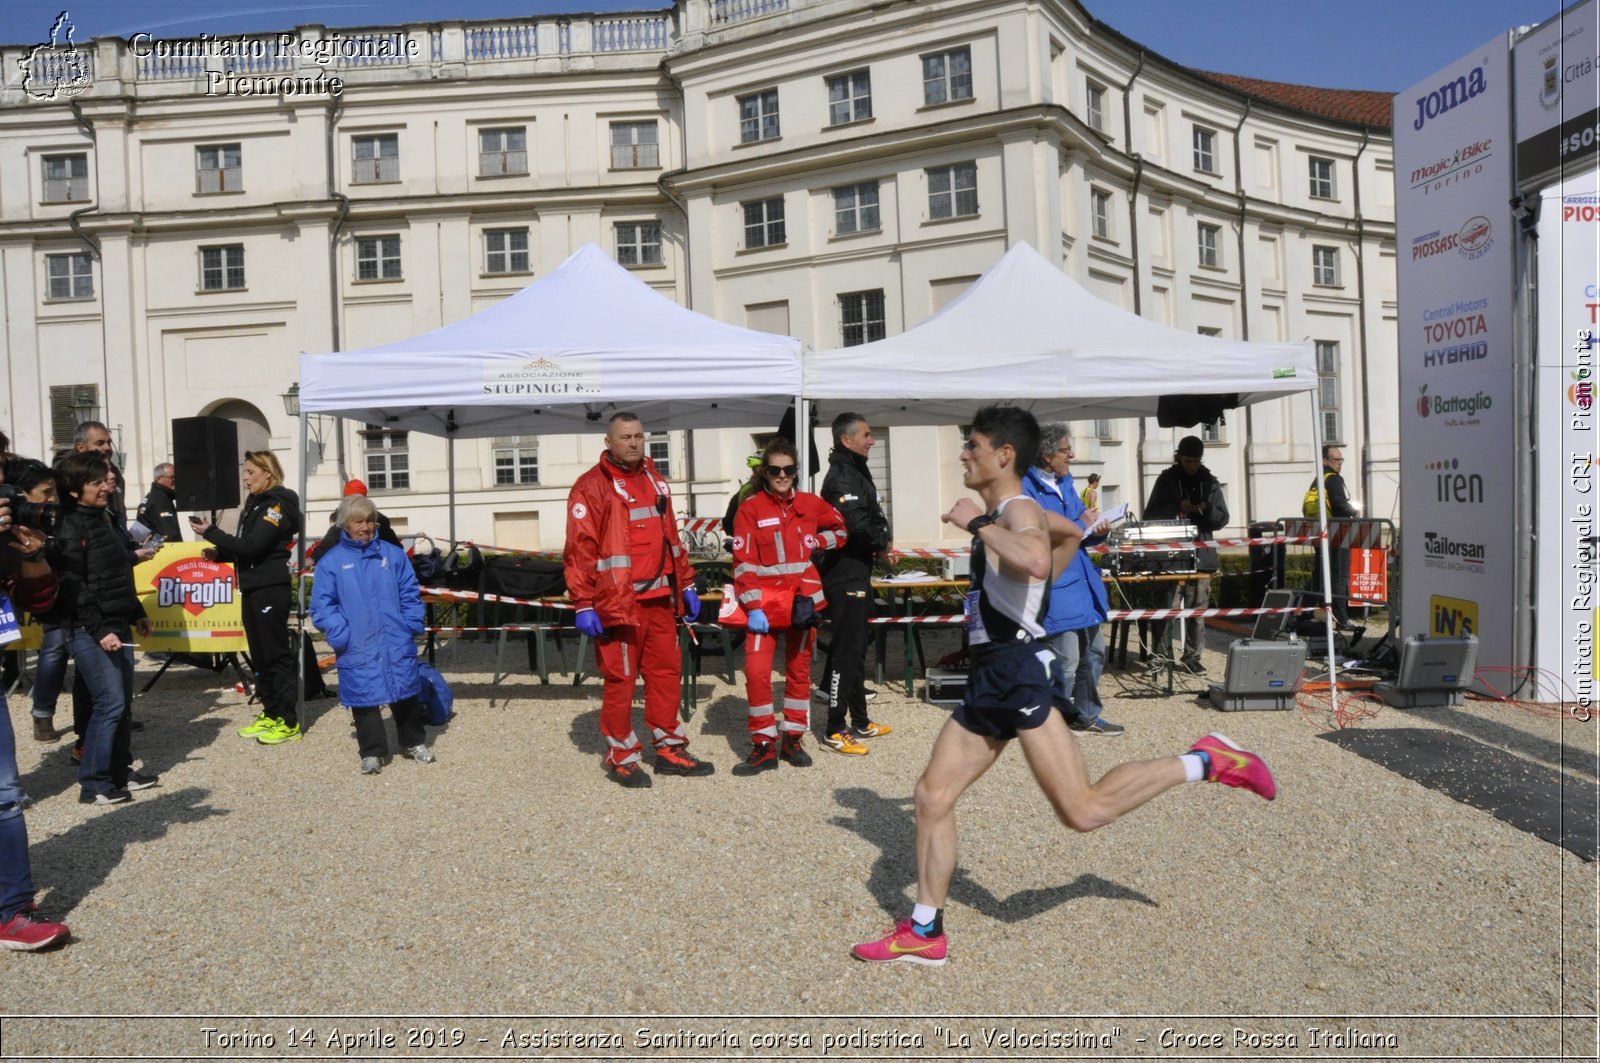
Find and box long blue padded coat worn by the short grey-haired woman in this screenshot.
[310,532,422,708]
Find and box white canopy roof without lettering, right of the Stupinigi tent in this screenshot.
[803,243,1317,426]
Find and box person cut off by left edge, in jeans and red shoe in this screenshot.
[0,486,72,953]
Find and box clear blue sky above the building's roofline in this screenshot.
[0,0,1562,91]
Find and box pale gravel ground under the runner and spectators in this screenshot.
[0,632,1597,1058]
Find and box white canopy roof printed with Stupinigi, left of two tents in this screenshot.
[299,243,800,437]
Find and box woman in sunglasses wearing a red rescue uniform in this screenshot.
[733,439,848,775]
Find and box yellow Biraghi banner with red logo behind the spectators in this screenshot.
[133,543,246,653]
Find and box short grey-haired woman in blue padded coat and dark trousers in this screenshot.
[310,495,434,775]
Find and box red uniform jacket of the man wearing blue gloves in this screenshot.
[562,453,694,628]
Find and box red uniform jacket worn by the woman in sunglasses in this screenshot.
[733,490,845,629]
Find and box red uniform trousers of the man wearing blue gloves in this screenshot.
[595,596,688,764]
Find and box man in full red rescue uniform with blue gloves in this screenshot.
[562,411,715,789]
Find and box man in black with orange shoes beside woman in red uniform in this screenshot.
[818,413,890,757]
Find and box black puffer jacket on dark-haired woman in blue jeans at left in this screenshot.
[50,506,144,639]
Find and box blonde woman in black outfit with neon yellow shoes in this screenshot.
[189,450,301,746]
